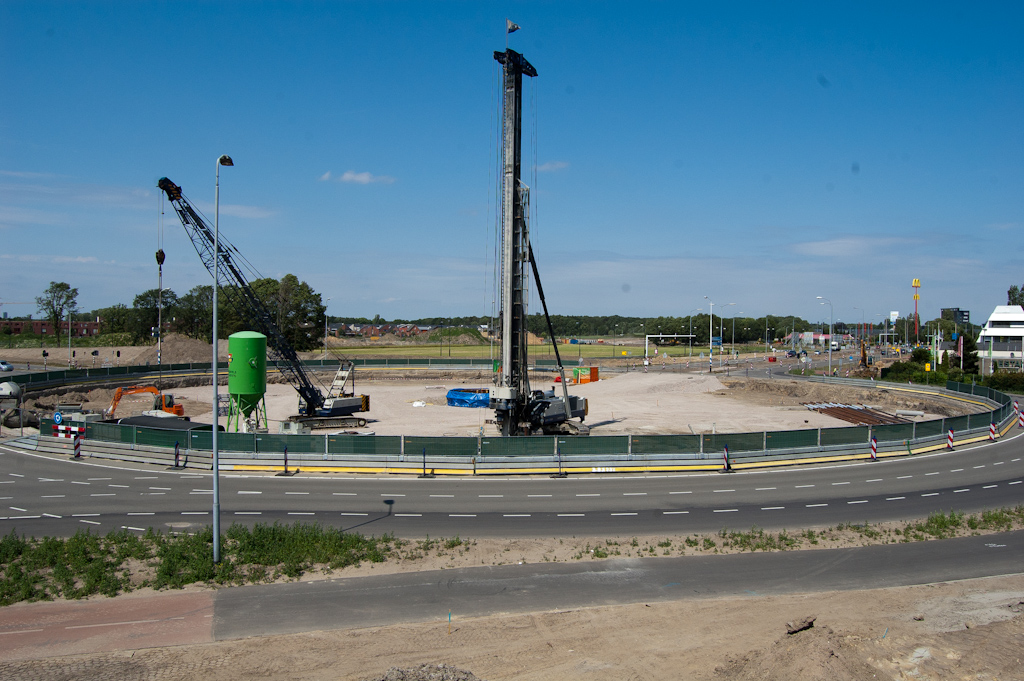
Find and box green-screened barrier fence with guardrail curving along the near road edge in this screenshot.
[29,381,1017,472]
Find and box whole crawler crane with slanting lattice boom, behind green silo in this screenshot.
[157,177,370,428]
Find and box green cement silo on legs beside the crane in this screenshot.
[227,331,266,432]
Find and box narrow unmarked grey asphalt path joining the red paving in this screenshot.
[213,530,1024,639]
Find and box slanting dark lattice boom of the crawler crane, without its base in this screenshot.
[157,177,325,416]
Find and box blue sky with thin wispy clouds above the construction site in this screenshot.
[0,0,1024,323]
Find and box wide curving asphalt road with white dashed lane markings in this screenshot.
[0,429,1024,538]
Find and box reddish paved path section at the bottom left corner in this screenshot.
[0,592,214,662]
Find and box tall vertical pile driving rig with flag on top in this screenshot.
[488,49,589,435]
